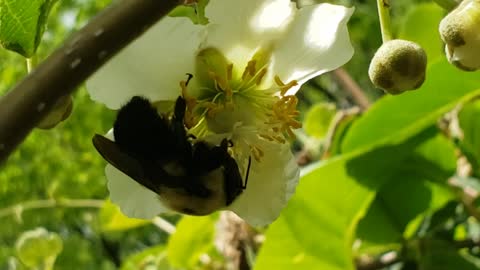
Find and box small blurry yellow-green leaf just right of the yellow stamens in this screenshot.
[303,103,336,139]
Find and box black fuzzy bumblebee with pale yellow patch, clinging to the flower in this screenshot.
[92,96,251,215]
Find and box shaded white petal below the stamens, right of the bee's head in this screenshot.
[227,143,300,226]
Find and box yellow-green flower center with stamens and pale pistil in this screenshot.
[180,47,301,161]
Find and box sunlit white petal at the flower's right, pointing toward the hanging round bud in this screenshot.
[274,4,354,94]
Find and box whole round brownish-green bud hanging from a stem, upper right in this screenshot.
[368,39,427,95]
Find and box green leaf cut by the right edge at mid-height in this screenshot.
[458,99,480,175]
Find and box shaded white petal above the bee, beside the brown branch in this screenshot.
[87,17,204,109]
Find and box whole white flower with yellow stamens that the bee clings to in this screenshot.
[87,0,353,226]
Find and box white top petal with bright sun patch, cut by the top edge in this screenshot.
[203,0,296,69]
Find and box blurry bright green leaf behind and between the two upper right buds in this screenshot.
[399,3,445,62]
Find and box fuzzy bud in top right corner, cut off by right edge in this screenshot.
[439,0,480,71]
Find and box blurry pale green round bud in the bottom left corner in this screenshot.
[15,228,63,269]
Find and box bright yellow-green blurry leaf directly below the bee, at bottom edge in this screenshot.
[167,215,216,269]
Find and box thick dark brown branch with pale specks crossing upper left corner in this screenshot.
[0,0,180,163]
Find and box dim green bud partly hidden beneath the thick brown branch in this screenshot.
[37,95,73,129]
